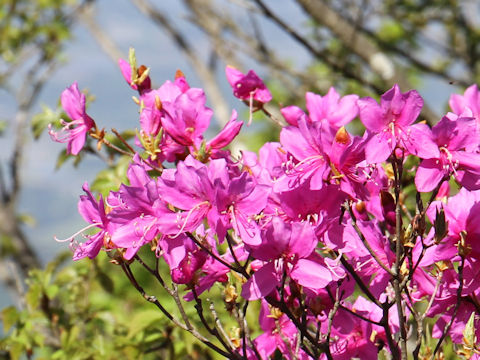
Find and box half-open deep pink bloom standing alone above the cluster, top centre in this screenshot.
[225,66,272,104]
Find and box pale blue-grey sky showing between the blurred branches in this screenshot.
[0,0,464,307]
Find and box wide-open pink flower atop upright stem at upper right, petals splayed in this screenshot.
[357,85,438,163]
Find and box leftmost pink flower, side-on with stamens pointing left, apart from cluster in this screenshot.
[48,82,95,155]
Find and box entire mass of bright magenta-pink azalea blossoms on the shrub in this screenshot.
[51,54,480,359]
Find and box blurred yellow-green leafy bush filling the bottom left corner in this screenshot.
[0,253,199,360]
